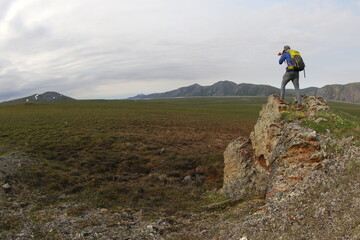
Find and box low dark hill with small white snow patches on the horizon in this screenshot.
[0,92,75,105]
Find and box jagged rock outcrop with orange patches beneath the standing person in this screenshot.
[222,95,329,200]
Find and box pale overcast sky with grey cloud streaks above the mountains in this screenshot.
[0,0,360,101]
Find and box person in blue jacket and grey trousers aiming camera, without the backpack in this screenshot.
[277,45,302,110]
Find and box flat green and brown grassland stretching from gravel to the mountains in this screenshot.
[0,97,360,214]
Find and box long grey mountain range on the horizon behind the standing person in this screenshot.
[129,81,360,103]
